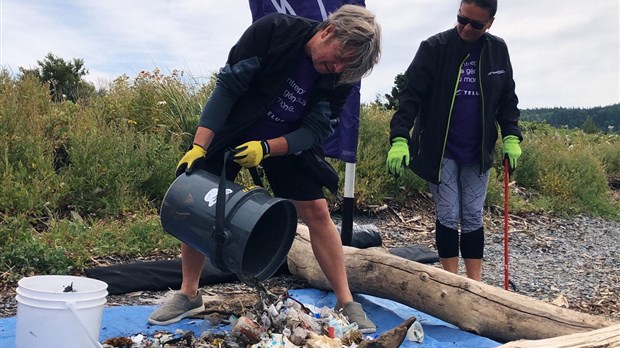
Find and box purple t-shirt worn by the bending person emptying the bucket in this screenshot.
[244,52,319,141]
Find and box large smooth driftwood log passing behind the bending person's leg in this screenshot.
[288,225,618,342]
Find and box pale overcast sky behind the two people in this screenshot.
[0,0,620,108]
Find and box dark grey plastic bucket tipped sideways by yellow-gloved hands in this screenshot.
[160,170,297,282]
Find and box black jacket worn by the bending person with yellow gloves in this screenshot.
[199,13,351,155]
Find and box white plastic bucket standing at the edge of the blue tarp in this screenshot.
[15,275,108,348]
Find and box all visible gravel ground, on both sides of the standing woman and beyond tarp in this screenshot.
[0,203,620,319]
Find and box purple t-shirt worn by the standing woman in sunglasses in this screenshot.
[445,43,482,165]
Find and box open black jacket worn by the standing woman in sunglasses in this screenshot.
[390,28,522,184]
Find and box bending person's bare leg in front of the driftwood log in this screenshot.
[293,199,353,305]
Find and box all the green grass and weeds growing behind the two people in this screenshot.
[0,71,620,281]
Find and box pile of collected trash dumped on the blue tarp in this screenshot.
[103,287,424,348]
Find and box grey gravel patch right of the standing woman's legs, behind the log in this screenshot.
[485,216,620,318]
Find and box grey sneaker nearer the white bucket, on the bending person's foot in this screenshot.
[149,293,204,325]
